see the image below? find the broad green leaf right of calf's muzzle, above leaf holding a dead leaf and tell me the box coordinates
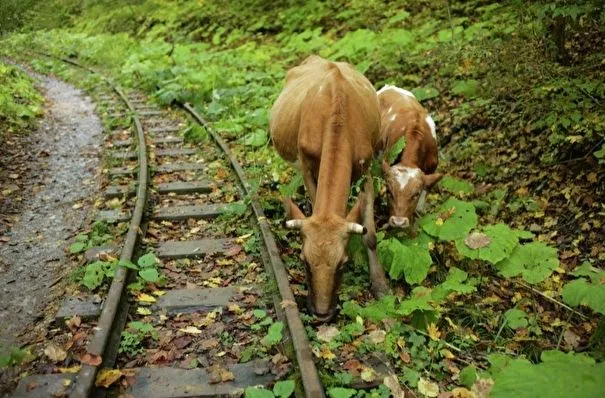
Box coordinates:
[419,198,477,240]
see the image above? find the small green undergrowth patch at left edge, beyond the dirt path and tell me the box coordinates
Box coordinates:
[0,62,44,142]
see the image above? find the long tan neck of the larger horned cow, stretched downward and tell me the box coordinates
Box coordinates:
[313,137,353,217]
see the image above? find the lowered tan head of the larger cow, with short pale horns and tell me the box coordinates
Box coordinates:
[284,199,366,321]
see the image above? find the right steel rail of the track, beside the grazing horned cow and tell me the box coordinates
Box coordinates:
[182,103,325,398]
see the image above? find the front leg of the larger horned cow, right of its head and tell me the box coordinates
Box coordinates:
[361,173,391,298]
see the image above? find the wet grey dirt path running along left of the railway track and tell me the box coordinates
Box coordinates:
[0,72,102,354]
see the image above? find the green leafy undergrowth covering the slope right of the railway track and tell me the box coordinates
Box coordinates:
[3,0,605,397]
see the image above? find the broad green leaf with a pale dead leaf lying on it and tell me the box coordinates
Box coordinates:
[456,224,519,264]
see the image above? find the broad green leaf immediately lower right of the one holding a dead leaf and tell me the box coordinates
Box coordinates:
[496,242,559,283]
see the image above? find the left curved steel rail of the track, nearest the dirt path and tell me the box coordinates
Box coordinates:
[38,52,149,398]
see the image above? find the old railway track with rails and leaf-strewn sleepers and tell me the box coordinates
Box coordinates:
[14,59,324,397]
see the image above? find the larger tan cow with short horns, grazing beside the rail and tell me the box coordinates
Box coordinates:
[270,56,388,320]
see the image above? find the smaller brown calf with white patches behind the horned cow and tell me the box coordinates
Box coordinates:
[377,85,443,228]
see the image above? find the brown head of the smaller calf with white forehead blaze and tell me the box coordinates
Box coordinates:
[382,161,443,228]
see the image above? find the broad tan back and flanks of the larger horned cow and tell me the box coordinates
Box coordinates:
[270,56,380,162]
